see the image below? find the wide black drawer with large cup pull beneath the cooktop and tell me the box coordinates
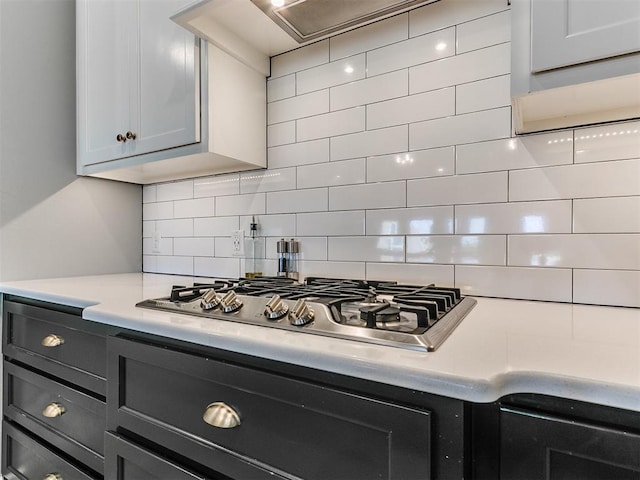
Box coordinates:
[108,338,431,480]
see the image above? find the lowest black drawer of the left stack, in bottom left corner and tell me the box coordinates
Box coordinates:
[2,422,100,480]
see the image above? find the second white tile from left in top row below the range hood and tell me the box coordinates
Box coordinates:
[329,13,409,61]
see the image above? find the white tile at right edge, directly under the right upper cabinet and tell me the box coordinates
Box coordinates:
[575,122,640,163]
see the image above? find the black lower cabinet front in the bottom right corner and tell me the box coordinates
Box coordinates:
[500,408,640,480]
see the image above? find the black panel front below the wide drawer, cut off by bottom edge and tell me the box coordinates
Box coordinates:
[104,432,205,480]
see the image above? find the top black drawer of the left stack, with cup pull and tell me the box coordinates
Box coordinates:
[3,301,106,395]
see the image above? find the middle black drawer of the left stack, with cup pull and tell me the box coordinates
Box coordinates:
[3,361,106,472]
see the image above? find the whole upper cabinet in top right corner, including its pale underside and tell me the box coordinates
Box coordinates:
[511,0,640,133]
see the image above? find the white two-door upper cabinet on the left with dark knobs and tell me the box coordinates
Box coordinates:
[76,0,266,184]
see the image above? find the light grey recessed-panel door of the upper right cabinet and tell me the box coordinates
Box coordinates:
[531,0,640,72]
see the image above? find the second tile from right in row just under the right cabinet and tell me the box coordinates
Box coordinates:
[456,132,573,174]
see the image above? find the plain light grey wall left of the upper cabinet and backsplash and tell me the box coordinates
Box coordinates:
[0,0,142,281]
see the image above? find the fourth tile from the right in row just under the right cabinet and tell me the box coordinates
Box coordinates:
[297,158,366,188]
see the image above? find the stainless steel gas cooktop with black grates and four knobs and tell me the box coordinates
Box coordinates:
[136,277,476,351]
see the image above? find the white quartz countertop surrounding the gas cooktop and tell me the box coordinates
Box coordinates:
[0,273,640,412]
